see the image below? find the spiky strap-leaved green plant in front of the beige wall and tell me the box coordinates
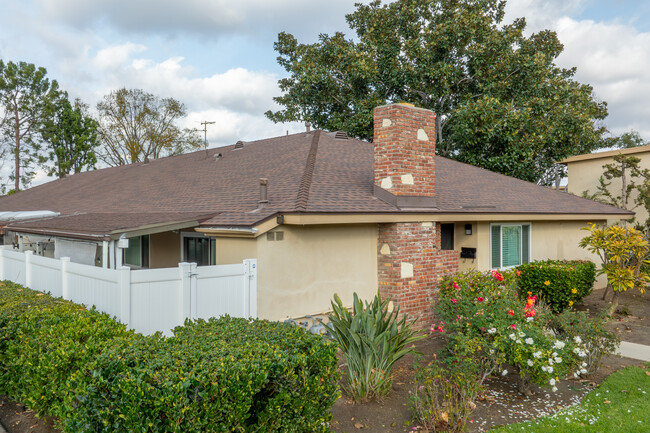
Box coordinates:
[328,293,424,401]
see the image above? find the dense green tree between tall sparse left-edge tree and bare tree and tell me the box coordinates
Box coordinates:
[42,92,99,178]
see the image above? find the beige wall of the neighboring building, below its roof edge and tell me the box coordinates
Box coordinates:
[567,152,650,222]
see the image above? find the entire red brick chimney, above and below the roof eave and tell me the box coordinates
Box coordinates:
[374,104,458,327]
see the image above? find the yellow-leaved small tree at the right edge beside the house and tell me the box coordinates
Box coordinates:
[580,224,650,314]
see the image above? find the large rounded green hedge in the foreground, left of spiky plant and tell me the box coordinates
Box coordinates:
[66,317,339,432]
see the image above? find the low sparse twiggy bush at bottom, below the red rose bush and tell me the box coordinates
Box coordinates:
[409,359,483,432]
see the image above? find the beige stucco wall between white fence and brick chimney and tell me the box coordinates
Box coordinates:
[257,224,377,320]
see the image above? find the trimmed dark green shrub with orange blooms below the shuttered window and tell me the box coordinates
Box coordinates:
[517,260,596,313]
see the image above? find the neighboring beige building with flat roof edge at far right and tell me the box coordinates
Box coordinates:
[560,145,650,222]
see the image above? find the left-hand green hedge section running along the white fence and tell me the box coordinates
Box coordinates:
[0,282,135,417]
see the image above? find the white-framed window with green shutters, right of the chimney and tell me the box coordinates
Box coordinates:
[490,224,530,269]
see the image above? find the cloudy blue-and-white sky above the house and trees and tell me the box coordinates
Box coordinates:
[0,0,650,183]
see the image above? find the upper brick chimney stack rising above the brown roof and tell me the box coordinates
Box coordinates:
[373,104,436,207]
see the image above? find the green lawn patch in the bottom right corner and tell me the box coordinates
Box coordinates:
[490,364,650,433]
